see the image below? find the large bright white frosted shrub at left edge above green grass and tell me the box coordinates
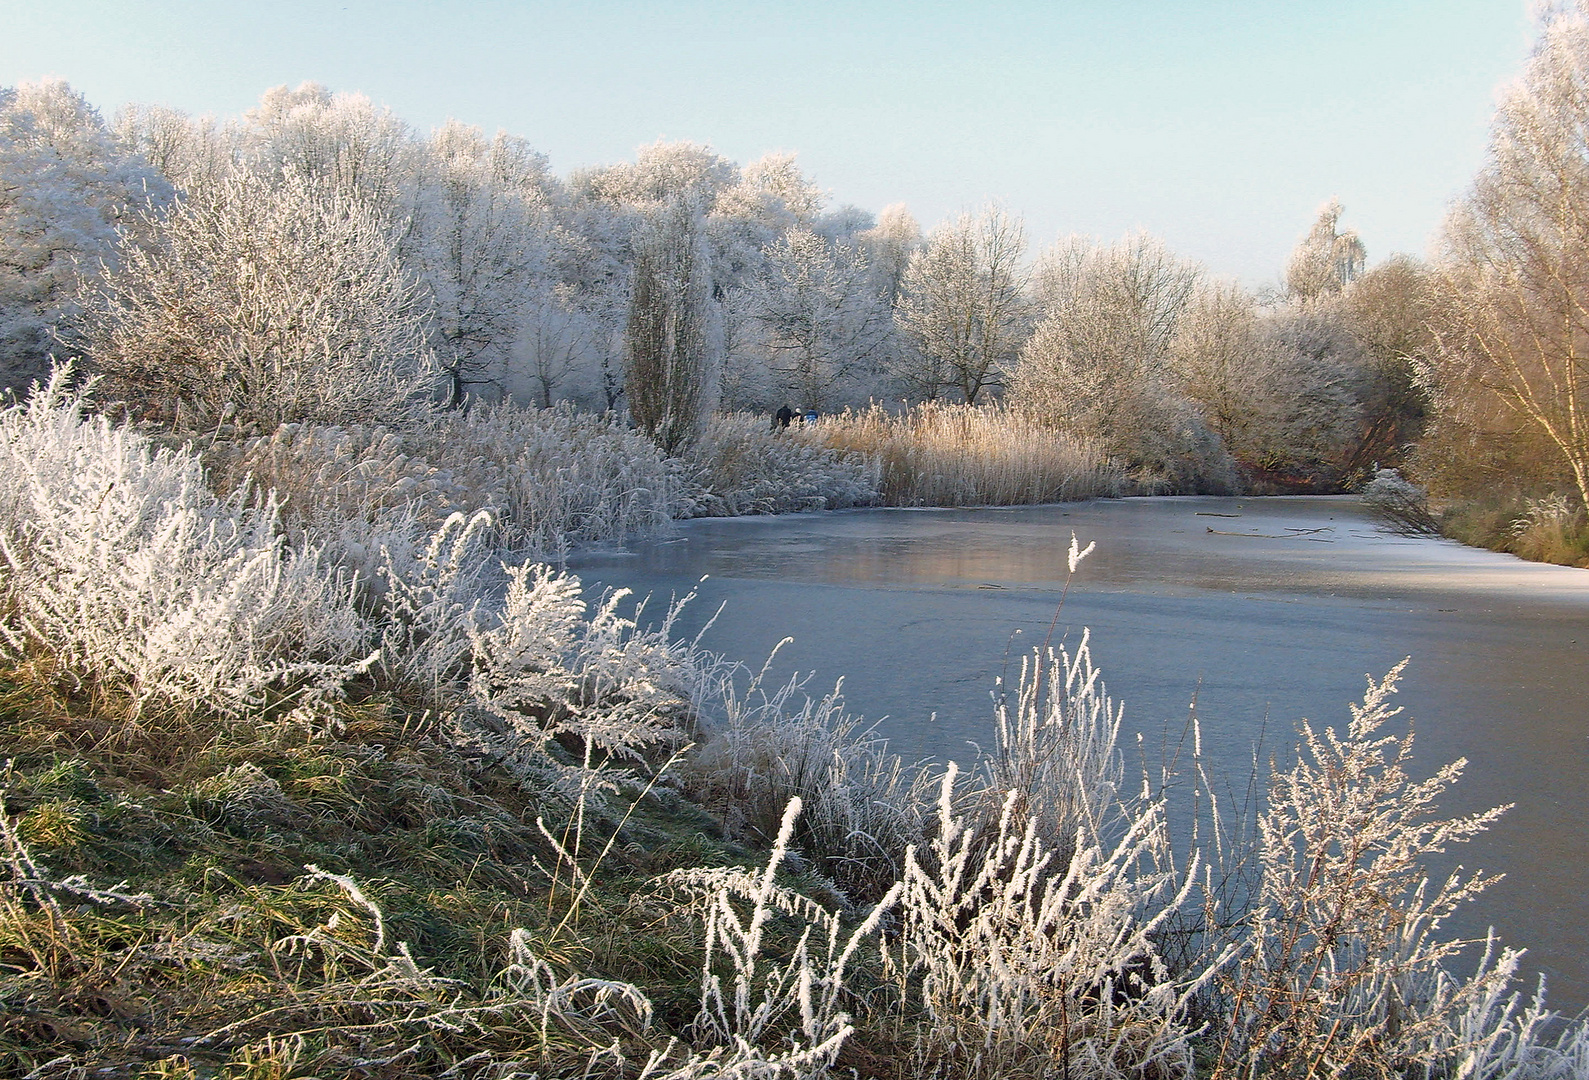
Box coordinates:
[0,370,369,713]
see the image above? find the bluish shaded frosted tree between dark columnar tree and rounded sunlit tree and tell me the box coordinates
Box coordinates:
[752,227,891,410]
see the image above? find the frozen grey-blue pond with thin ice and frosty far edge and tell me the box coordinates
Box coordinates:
[572,497,1589,1012]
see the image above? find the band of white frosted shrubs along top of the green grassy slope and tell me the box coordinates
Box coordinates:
[0,368,699,775]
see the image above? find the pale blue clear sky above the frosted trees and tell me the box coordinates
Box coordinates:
[0,0,1532,283]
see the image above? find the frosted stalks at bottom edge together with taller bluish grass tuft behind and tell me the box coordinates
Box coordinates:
[887,616,1227,1077]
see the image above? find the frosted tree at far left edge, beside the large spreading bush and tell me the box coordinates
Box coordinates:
[0,79,170,391]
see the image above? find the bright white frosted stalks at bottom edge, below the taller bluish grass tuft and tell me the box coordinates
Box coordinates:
[887,766,1201,1077]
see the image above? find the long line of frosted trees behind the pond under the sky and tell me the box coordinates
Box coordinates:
[9,83,1419,491]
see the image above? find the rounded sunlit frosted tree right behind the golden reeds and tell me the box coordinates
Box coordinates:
[895,206,1028,405]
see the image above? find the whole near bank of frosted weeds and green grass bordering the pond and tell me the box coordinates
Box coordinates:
[0,381,1589,1080]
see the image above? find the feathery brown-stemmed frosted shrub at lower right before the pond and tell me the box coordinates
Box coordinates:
[1216,662,1519,1077]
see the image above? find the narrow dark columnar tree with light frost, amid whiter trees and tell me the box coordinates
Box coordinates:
[624,199,713,454]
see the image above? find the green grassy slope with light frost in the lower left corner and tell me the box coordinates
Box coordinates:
[0,669,752,1077]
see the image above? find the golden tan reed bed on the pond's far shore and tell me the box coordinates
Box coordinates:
[791,402,1127,507]
